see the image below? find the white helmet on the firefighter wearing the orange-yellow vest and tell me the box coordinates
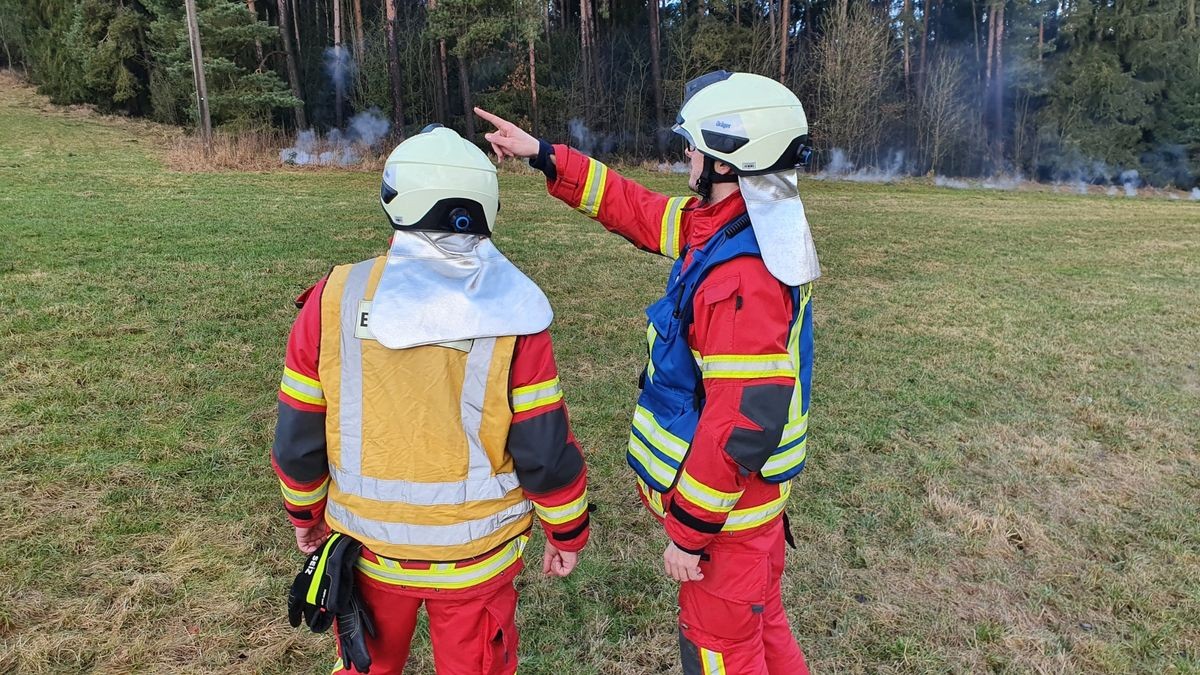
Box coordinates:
[379,124,500,237]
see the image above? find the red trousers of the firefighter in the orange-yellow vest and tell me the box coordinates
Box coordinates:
[334,565,521,675]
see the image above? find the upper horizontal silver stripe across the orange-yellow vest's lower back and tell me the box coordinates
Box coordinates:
[330,467,521,506]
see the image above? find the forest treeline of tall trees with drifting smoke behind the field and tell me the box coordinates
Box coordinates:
[0,0,1200,183]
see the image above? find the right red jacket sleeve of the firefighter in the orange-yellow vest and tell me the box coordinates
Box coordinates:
[508,330,589,551]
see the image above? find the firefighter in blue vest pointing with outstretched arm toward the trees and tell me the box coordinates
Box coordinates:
[476,71,820,675]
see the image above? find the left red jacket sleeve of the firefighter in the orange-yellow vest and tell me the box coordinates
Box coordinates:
[271,279,329,527]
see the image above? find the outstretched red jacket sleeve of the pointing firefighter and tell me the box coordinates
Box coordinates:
[546,145,695,259]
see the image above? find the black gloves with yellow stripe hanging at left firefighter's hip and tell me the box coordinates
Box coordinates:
[288,532,376,673]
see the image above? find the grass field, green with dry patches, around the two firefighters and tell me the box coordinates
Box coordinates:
[0,73,1200,675]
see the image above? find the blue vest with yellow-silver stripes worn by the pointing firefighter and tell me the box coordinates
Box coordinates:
[625,215,812,492]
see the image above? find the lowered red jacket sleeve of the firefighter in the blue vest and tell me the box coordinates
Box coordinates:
[666,257,796,554]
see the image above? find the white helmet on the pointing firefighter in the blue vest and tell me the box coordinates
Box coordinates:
[671,71,810,175]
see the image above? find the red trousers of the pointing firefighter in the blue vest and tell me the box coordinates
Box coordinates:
[679,519,809,675]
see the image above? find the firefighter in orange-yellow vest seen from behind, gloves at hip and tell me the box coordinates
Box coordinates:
[271,125,588,675]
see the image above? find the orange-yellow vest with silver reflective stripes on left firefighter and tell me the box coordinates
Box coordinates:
[318,257,533,561]
